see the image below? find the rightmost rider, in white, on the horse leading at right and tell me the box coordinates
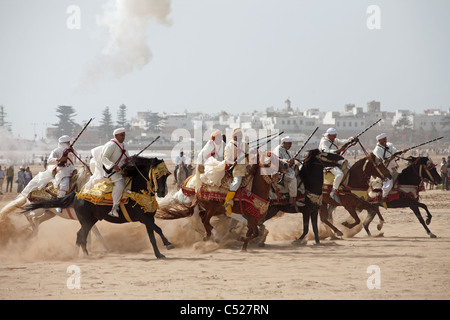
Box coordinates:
[373,133,408,199]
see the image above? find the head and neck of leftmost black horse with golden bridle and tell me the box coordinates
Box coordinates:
[124,157,171,198]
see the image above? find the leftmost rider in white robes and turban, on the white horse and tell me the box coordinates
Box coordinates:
[47,135,75,212]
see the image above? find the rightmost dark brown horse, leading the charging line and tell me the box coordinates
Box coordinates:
[363,157,442,238]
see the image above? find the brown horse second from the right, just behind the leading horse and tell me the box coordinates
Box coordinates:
[319,153,391,236]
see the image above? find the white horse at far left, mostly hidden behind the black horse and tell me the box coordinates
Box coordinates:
[0,167,109,251]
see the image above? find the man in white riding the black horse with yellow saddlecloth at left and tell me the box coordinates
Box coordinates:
[101,128,129,218]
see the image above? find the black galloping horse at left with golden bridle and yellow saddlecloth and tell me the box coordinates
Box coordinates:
[25,157,173,259]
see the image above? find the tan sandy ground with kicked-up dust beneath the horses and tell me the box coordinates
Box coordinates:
[0,162,450,300]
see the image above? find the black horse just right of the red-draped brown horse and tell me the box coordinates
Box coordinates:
[260,149,344,245]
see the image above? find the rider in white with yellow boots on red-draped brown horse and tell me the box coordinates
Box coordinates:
[224,128,248,215]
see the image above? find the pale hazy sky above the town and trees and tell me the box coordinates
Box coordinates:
[0,0,450,138]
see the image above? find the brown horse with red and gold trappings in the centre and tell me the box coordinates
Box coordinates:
[158,152,284,251]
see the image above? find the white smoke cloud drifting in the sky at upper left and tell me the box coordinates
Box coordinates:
[83,0,172,86]
